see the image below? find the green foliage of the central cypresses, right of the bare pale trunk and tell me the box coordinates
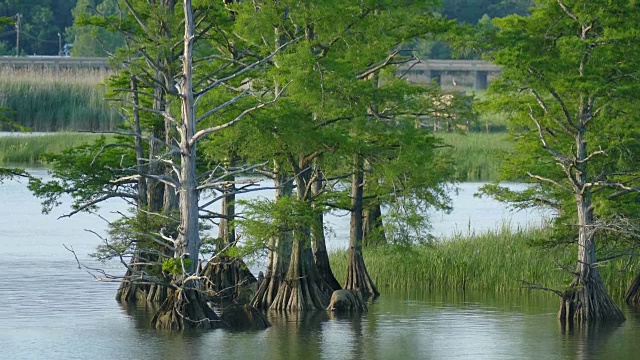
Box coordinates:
[210,1,464,245]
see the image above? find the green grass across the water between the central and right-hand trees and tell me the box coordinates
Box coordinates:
[437,133,511,181]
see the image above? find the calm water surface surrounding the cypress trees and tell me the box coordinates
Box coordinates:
[0,171,640,360]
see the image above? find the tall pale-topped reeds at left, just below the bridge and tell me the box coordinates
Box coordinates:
[0,69,118,132]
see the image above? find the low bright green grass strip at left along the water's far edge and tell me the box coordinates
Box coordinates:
[0,133,106,166]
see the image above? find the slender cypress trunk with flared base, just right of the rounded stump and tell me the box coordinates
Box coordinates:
[344,153,380,297]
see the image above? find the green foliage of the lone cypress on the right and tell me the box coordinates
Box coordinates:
[484,1,640,246]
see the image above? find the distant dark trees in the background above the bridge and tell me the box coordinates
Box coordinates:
[0,0,533,58]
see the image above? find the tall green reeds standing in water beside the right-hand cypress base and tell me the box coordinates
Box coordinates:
[330,229,640,299]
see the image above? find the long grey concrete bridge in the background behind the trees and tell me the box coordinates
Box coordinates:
[0,56,500,89]
